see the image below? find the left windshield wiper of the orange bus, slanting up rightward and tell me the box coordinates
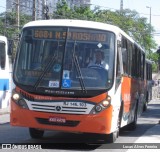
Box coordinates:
[34,50,58,90]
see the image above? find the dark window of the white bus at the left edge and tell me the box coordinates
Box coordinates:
[0,43,6,69]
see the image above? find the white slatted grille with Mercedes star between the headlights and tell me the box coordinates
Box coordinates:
[26,100,95,114]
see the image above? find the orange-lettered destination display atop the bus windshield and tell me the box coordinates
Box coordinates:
[33,30,107,42]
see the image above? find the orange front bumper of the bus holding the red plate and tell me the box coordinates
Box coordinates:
[10,102,113,134]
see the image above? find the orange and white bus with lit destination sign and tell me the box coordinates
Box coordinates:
[10,20,145,142]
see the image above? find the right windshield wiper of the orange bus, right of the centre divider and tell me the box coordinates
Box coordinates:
[72,41,87,93]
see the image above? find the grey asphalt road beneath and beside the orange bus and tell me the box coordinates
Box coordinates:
[0,100,160,152]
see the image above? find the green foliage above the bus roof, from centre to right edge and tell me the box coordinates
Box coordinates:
[53,0,157,67]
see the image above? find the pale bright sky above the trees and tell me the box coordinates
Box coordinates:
[0,0,160,46]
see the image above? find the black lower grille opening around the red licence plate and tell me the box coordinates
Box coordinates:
[36,118,80,127]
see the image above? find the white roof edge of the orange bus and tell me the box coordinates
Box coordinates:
[23,19,144,51]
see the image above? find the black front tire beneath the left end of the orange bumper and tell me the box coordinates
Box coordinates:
[29,128,44,139]
